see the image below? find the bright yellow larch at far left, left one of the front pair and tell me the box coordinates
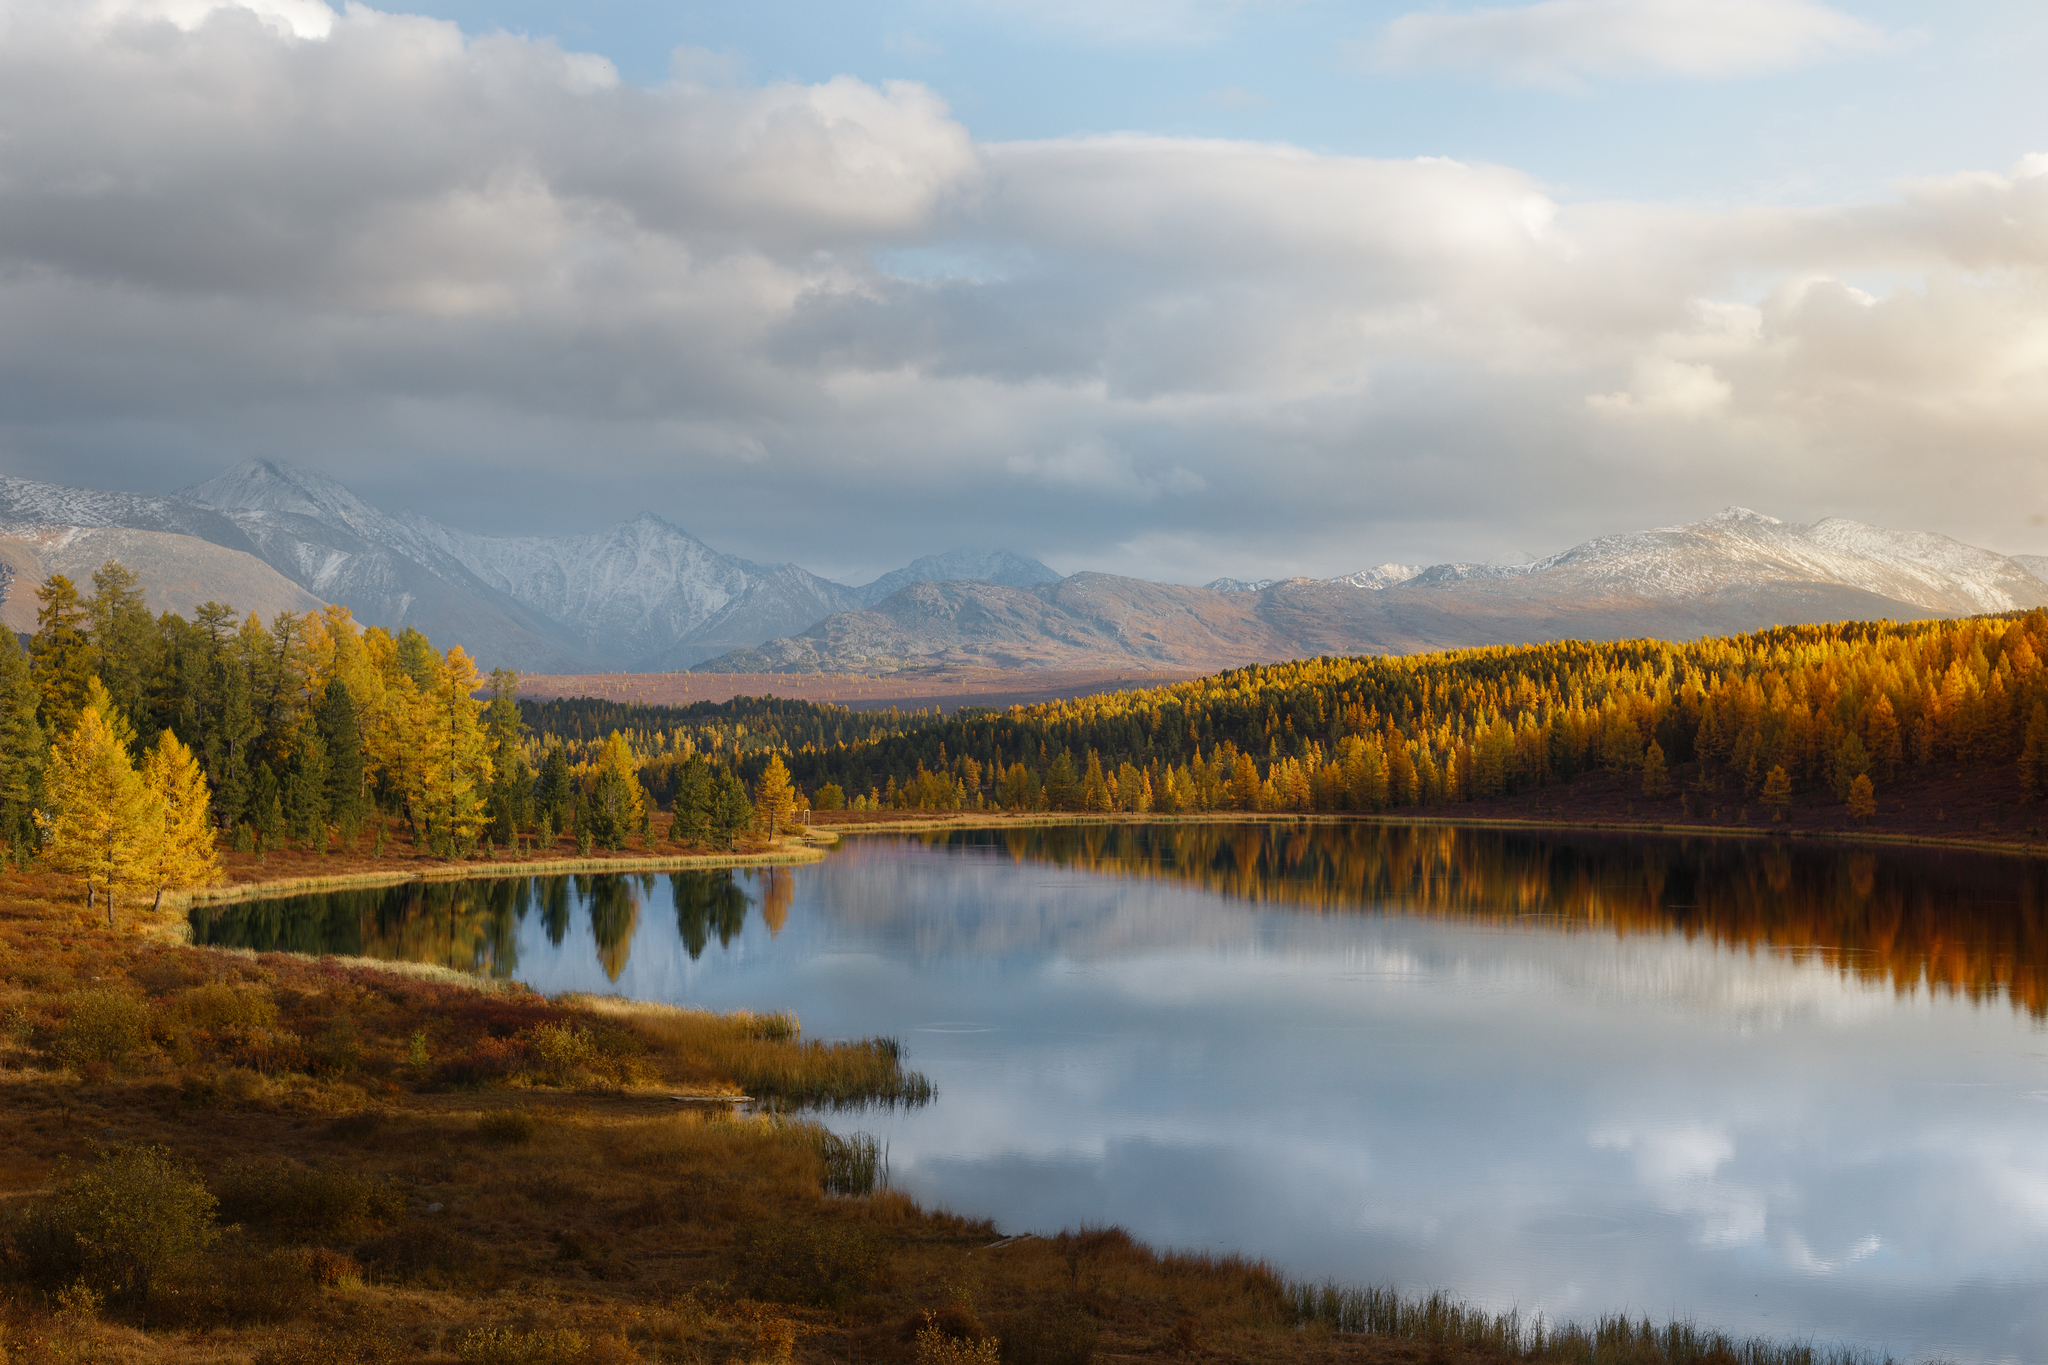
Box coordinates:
[45,677,164,929]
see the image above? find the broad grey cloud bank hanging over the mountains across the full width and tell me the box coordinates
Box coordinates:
[0,0,2048,581]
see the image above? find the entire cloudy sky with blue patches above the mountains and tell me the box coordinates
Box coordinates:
[0,0,2048,583]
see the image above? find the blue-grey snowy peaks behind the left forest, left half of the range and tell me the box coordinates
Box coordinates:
[0,460,1059,673]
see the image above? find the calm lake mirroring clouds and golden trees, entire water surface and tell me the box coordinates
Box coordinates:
[195,825,2048,1361]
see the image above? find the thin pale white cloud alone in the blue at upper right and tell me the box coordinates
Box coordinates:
[1366,0,1884,88]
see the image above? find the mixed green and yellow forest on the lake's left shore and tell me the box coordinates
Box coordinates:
[0,563,801,898]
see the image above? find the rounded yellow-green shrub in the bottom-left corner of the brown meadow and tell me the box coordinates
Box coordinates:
[12,1146,219,1295]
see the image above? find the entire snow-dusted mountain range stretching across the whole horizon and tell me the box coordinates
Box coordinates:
[0,460,2048,673]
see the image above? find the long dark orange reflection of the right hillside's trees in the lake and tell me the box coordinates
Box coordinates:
[924,825,2048,1019]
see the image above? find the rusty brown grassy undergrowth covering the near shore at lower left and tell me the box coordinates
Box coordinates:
[0,872,1900,1365]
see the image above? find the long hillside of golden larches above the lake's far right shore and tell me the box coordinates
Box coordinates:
[753,610,2048,812]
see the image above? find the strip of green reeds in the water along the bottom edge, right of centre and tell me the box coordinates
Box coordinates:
[1284,1281,1892,1365]
